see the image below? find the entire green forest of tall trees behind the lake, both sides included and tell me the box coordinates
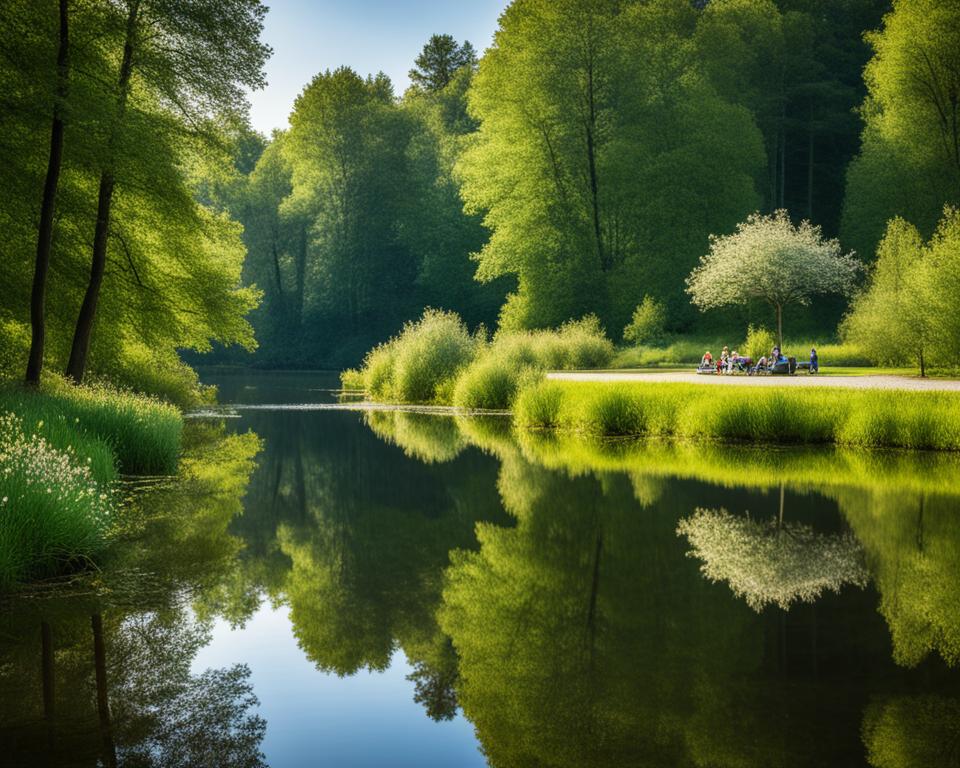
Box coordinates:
[0,0,960,384]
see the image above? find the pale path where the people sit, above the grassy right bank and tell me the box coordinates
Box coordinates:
[547,371,960,392]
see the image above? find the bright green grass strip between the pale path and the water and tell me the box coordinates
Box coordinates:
[515,381,960,451]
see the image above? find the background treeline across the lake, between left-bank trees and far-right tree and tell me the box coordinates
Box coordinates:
[206,0,920,365]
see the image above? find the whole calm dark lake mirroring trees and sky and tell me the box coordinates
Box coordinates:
[0,372,960,768]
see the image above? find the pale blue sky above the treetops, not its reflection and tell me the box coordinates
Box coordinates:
[250,0,508,134]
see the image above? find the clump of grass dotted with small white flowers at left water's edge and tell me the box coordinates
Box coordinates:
[0,413,113,587]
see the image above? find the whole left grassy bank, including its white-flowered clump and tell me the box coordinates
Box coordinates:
[0,381,183,588]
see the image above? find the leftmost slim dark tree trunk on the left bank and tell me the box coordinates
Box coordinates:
[26,0,70,386]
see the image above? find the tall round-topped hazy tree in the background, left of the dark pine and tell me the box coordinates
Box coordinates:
[283,67,415,350]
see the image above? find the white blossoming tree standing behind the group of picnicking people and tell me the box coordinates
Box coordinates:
[687,210,863,349]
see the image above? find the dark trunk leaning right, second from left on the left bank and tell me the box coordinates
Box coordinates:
[66,0,140,384]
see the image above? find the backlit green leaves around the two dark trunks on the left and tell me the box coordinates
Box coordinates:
[0,0,268,390]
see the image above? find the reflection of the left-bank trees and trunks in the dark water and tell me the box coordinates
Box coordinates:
[0,425,265,768]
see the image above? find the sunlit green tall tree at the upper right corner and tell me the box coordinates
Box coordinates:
[843,0,960,253]
